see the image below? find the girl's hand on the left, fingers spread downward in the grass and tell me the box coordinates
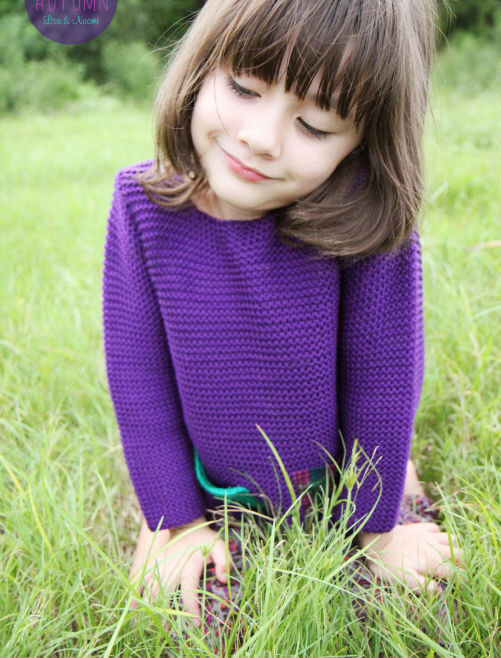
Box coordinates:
[129,517,231,627]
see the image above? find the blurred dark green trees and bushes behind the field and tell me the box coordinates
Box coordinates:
[0,0,501,114]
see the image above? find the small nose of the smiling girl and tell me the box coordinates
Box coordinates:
[238,107,284,159]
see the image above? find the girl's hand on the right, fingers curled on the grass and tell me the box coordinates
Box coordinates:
[359,523,463,591]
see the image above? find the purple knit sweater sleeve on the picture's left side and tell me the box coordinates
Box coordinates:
[103,172,206,530]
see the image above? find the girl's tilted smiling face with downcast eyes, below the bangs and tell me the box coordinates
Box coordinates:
[191,67,362,219]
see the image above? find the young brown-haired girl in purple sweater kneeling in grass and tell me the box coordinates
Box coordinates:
[103,0,460,644]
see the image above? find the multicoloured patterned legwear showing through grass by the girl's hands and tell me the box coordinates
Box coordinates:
[164,494,459,656]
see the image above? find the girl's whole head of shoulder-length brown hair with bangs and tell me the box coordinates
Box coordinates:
[137,0,436,257]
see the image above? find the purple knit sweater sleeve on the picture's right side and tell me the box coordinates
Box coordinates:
[338,232,424,532]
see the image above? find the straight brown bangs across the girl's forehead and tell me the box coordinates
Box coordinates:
[213,0,367,123]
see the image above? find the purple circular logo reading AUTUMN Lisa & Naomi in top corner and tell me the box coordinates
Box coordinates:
[25,0,118,45]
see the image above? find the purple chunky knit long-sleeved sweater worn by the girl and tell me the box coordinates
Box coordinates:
[103,161,424,532]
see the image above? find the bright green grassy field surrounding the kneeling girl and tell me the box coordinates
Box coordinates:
[0,34,501,658]
